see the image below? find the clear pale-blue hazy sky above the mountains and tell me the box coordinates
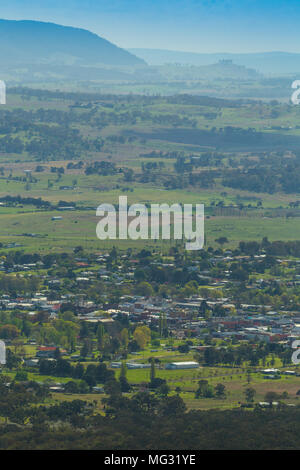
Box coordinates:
[0,0,300,52]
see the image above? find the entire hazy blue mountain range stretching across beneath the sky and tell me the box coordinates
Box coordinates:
[0,19,300,86]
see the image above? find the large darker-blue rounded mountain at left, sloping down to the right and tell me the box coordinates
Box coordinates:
[0,20,146,66]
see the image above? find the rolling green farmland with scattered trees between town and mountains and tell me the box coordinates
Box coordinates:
[0,89,300,251]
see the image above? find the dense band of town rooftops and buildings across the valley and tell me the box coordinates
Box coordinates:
[0,277,300,348]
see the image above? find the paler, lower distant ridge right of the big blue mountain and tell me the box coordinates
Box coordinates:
[128,48,300,75]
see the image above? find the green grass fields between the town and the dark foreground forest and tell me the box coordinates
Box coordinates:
[4,340,300,413]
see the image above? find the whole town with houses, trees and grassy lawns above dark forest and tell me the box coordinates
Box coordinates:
[0,239,300,412]
